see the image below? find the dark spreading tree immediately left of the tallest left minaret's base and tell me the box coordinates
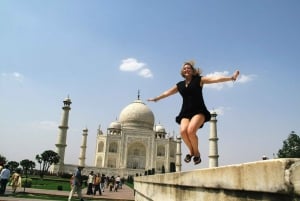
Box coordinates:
[35,150,60,178]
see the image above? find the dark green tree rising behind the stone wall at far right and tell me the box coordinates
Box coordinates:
[277,131,300,158]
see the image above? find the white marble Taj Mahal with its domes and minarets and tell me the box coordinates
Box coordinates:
[50,94,218,178]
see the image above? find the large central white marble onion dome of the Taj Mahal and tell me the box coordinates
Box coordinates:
[119,99,154,130]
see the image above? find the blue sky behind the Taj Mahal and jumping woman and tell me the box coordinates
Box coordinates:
[0,0,300,170]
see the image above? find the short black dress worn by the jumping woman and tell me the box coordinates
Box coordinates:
[176,76,211,128]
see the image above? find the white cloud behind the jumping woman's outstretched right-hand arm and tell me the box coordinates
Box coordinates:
[205,71,255,90]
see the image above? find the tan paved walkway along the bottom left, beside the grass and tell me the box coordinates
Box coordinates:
[0,185,134,201]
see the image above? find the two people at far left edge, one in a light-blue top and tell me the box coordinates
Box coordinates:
[0,165,22,195]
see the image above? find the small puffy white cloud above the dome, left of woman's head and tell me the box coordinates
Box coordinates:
[120,58,153,78]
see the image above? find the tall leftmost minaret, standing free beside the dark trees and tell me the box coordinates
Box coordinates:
[54,97,72,173]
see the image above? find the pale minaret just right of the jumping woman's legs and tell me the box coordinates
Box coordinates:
[208,112,219,168]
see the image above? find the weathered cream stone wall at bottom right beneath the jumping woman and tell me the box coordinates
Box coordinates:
[134,159,300,201]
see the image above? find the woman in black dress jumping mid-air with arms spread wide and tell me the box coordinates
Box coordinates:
[148,61,239,165]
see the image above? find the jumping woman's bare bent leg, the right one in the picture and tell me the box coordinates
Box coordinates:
[187,114,205,157]
